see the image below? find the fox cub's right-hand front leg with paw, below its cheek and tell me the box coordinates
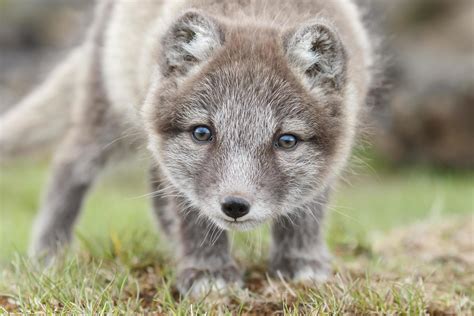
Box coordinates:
[270,190,330,282]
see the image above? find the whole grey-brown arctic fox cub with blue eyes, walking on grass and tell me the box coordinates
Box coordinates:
[0,0,373,293]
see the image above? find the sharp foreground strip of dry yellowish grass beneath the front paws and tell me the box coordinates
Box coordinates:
[0,216,474,315]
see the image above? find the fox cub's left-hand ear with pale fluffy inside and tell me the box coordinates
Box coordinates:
[161,11,224,75]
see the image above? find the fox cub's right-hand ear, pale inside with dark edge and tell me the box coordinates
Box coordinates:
[283,24,346,90]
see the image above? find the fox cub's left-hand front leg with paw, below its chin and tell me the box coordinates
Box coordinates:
[159,198,241,297]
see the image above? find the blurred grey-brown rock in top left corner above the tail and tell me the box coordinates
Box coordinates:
[0,0,93,113]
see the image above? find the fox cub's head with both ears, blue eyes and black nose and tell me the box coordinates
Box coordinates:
[143,11,346,230]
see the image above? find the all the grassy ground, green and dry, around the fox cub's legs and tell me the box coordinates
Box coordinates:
[0,153,474,315]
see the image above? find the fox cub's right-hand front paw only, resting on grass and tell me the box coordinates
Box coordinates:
[270,258,331,284]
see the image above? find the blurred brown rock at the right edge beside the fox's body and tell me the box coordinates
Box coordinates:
[374,0,474,168]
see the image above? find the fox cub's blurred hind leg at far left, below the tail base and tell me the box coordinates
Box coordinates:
[30,77,126,260]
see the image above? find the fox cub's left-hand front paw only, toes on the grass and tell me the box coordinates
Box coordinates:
[176,265,243,298]
